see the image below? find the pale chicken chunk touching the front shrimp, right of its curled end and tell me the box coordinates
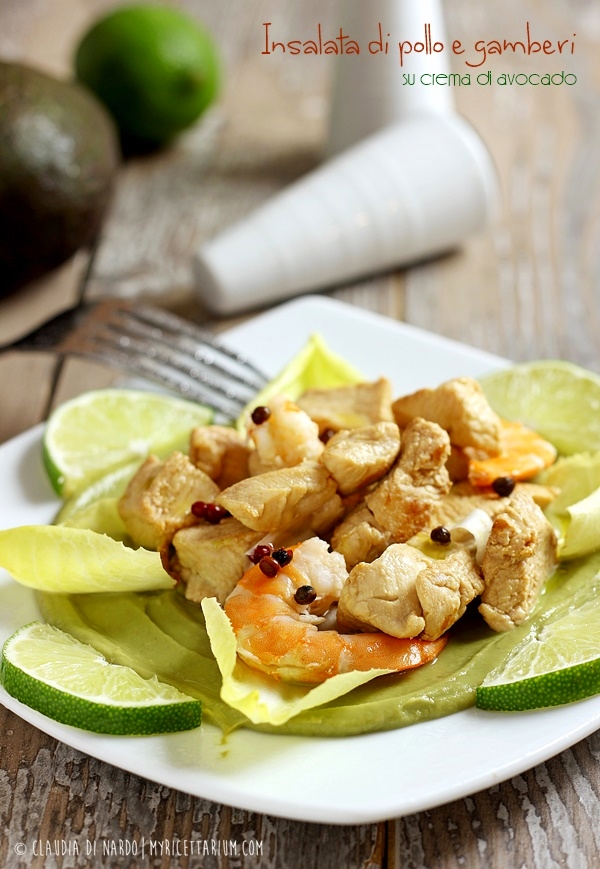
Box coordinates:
[337,543,430,637]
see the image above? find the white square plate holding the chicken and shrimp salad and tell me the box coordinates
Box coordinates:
[0,297,600,824]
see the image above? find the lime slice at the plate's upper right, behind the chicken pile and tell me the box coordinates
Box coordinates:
[481,360,600,455]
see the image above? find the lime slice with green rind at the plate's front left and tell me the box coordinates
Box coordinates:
[0,622,202,735]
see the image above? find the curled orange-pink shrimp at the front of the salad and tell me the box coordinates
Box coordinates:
[225,538,446,683]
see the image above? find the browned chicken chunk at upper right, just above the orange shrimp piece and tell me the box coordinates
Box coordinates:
[392,377,501,455]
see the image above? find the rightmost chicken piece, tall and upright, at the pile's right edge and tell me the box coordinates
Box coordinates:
[479,492,557,631]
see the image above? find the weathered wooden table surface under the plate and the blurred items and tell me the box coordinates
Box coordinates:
[0,0,600,869]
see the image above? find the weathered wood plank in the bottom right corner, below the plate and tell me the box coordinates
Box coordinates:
[390,733,600,869]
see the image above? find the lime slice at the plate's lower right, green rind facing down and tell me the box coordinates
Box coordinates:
[476,577,600,711]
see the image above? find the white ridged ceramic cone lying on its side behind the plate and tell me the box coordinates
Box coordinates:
[194,114,496,315]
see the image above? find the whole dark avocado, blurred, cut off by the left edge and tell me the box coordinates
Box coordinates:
[0,62,120,295]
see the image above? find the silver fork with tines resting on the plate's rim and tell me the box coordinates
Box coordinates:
[0,300,268,420]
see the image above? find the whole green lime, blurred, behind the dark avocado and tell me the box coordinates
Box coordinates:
[75,4,219,144]
